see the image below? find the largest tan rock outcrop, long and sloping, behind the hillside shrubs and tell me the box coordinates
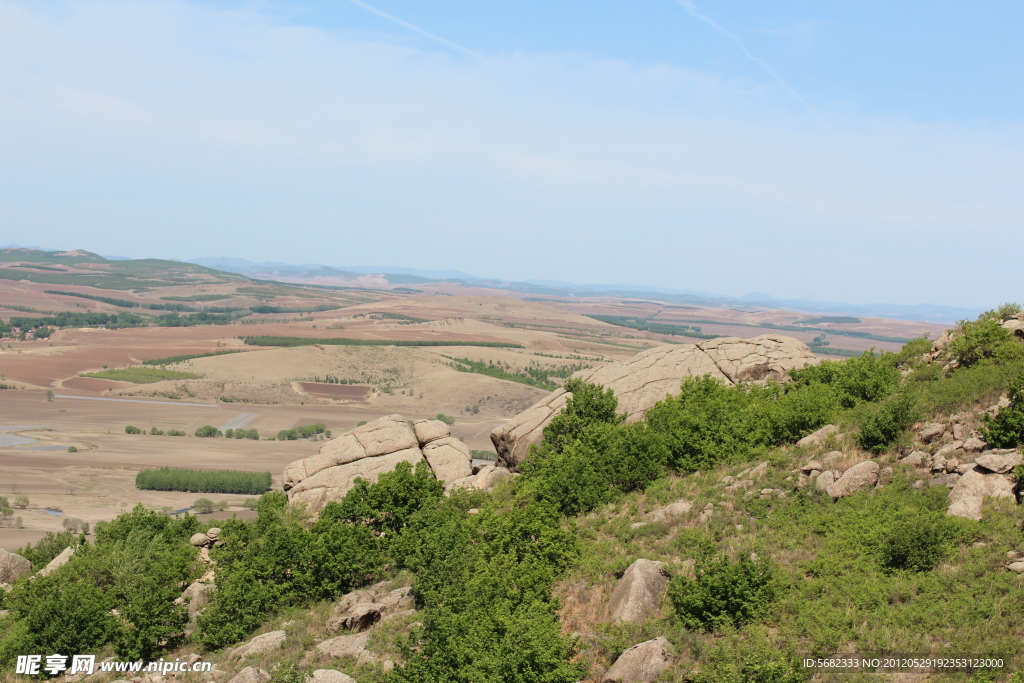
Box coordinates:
[490,335,818,469]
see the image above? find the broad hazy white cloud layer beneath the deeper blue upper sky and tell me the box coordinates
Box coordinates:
[0,0,1024,305]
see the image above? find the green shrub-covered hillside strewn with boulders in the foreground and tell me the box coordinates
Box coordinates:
[0,307,1024,683]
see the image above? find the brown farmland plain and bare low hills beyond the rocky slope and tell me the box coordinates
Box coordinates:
[0,264,943,548]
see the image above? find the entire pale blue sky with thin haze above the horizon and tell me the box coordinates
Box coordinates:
[0,0,1024,307]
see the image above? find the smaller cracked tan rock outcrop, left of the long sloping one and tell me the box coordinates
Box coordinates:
[284,415,473,511]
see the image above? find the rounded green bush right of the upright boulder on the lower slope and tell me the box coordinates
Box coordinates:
[668,553,779,631]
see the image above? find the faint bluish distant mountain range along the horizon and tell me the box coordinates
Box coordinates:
[187,256,984,324]
